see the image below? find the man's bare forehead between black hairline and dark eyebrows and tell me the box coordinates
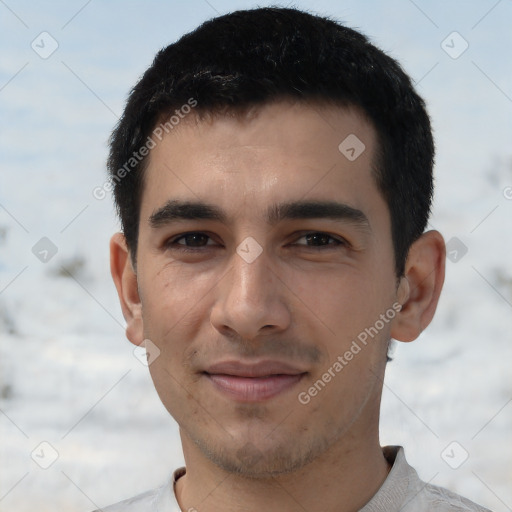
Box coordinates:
[141,103,382,222]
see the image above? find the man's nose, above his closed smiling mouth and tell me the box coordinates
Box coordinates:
[211,249,291,341]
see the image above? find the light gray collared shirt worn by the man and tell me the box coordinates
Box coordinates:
[94,446,490,512]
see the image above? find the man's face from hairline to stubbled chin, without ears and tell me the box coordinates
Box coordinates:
[131,103,398,477]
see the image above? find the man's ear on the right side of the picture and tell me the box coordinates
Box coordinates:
[391,231,446,341]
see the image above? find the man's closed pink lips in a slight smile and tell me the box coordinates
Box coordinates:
[204,361,307,402]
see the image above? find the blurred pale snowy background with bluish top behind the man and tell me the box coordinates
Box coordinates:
[0,0,512,512]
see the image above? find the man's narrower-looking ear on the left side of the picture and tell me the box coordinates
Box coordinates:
[110,233,144,345]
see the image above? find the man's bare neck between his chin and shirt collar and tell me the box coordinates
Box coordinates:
[176,425,390,512]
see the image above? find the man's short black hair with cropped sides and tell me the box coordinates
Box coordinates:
[108,7,434,277]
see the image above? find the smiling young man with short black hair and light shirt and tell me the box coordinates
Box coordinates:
[104,8,492,512]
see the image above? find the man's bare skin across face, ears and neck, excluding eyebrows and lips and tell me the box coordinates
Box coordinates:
[111,103,445,512]
